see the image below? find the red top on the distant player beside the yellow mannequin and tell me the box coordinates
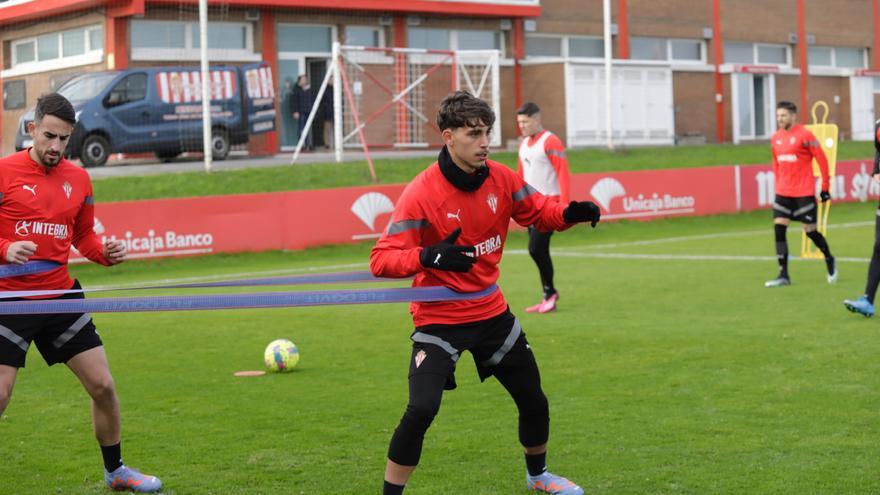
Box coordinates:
[770,124,830,198]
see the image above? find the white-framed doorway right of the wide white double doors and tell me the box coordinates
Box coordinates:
[731,72,776,143]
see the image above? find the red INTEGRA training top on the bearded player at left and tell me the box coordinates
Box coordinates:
[0,148,110,291]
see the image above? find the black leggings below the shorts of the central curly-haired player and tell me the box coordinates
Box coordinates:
[388,360,550,466]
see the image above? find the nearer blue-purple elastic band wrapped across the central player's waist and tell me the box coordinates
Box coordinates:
[0,284,498,315]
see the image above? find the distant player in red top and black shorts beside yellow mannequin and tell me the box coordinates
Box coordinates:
[764,101,837,287]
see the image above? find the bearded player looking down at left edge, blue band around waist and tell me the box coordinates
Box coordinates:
[0,93,162,492]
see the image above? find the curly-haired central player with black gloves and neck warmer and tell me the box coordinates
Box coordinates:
[370,92,599,495]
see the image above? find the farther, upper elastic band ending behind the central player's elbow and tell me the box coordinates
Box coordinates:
[0,270,392,299]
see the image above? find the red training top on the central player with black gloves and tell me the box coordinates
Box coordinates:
[370,160,572,327]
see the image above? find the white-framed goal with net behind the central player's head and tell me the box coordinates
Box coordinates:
[328,45,501,167]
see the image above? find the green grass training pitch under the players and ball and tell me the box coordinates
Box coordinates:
[0,204,880,495]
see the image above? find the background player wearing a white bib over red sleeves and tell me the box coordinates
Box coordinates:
[516,101,570,313]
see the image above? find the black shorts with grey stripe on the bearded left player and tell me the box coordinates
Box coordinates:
[0,281,103,368]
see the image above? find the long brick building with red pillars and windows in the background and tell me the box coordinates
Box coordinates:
[0,0,880,154]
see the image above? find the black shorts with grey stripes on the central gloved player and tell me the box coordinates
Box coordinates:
[409,308,535,390]
